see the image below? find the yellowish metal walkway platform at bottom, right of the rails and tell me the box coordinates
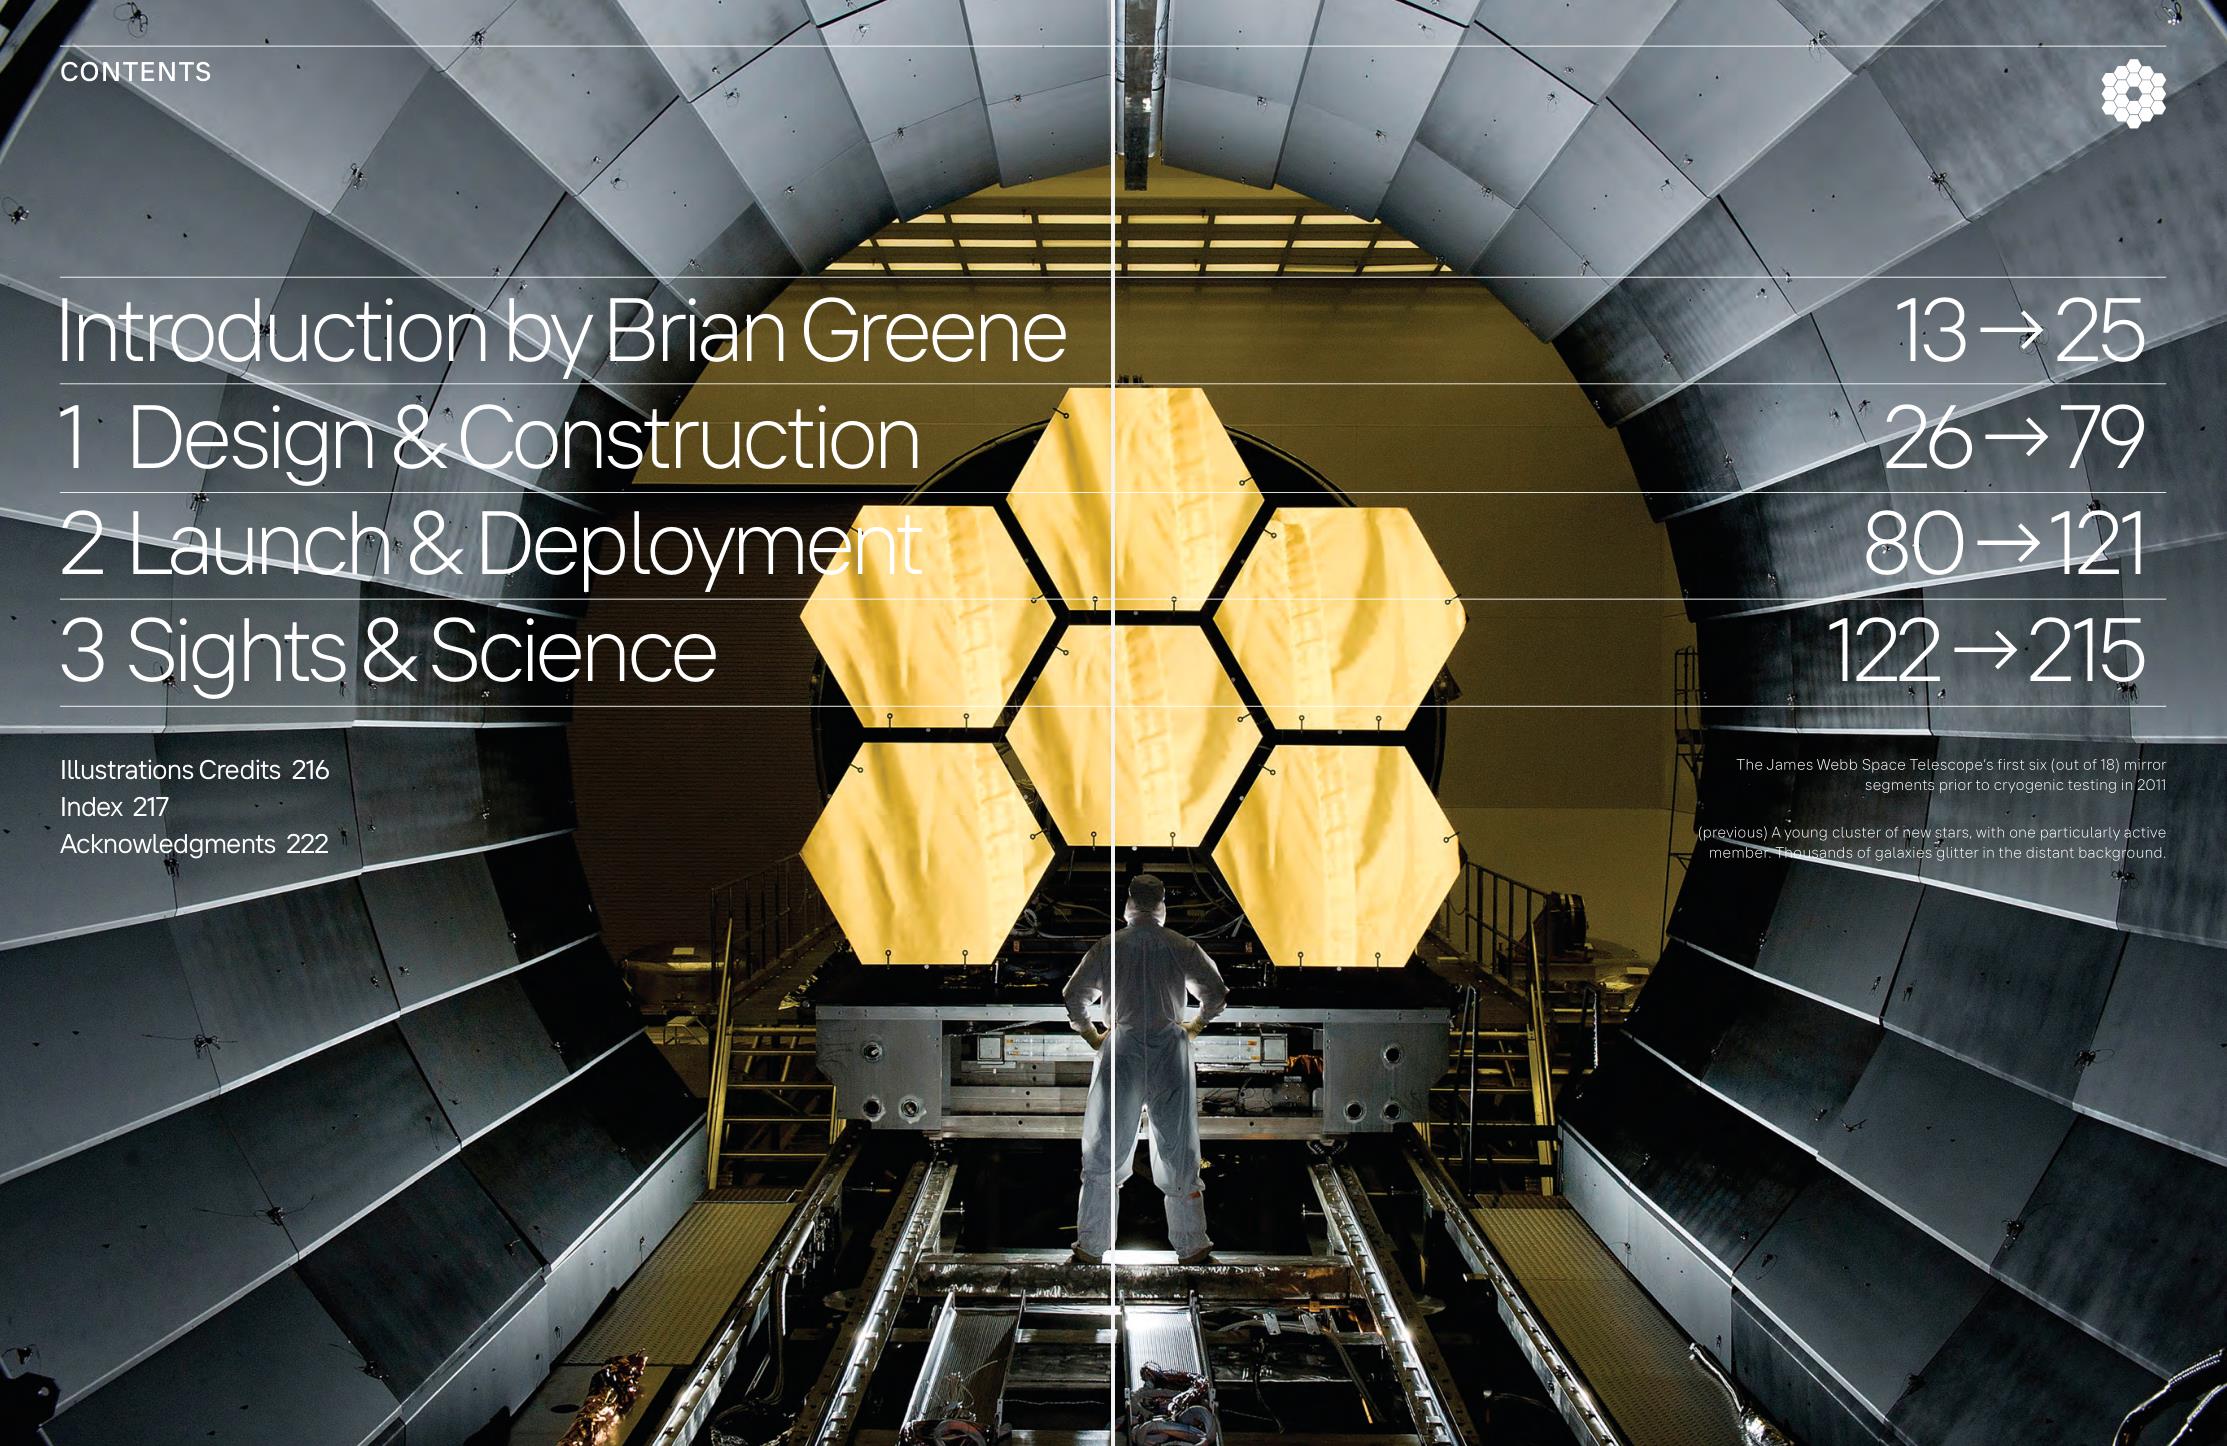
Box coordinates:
[1470,1194,1735,1446]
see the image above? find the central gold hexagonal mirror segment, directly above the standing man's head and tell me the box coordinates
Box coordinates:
[1009,624,1260,849]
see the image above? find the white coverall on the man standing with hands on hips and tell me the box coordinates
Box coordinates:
[1065,907,1229,1254]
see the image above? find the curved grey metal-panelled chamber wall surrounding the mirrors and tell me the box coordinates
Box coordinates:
[0,0,2227,1444]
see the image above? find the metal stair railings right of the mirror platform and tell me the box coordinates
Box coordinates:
[1436,858,1572,1183]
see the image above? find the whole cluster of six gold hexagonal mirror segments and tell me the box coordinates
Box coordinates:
[804,388,1465,967]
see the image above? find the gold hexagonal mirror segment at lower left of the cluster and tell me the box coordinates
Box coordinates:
[804,742,1051,965]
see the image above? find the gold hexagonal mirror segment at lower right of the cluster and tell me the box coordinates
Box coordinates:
[1214,744,1461,969]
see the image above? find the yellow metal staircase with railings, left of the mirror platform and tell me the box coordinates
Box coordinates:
[706,853,842,1190]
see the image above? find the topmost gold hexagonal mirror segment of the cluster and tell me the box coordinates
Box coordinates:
[1011,388,1260,610]
